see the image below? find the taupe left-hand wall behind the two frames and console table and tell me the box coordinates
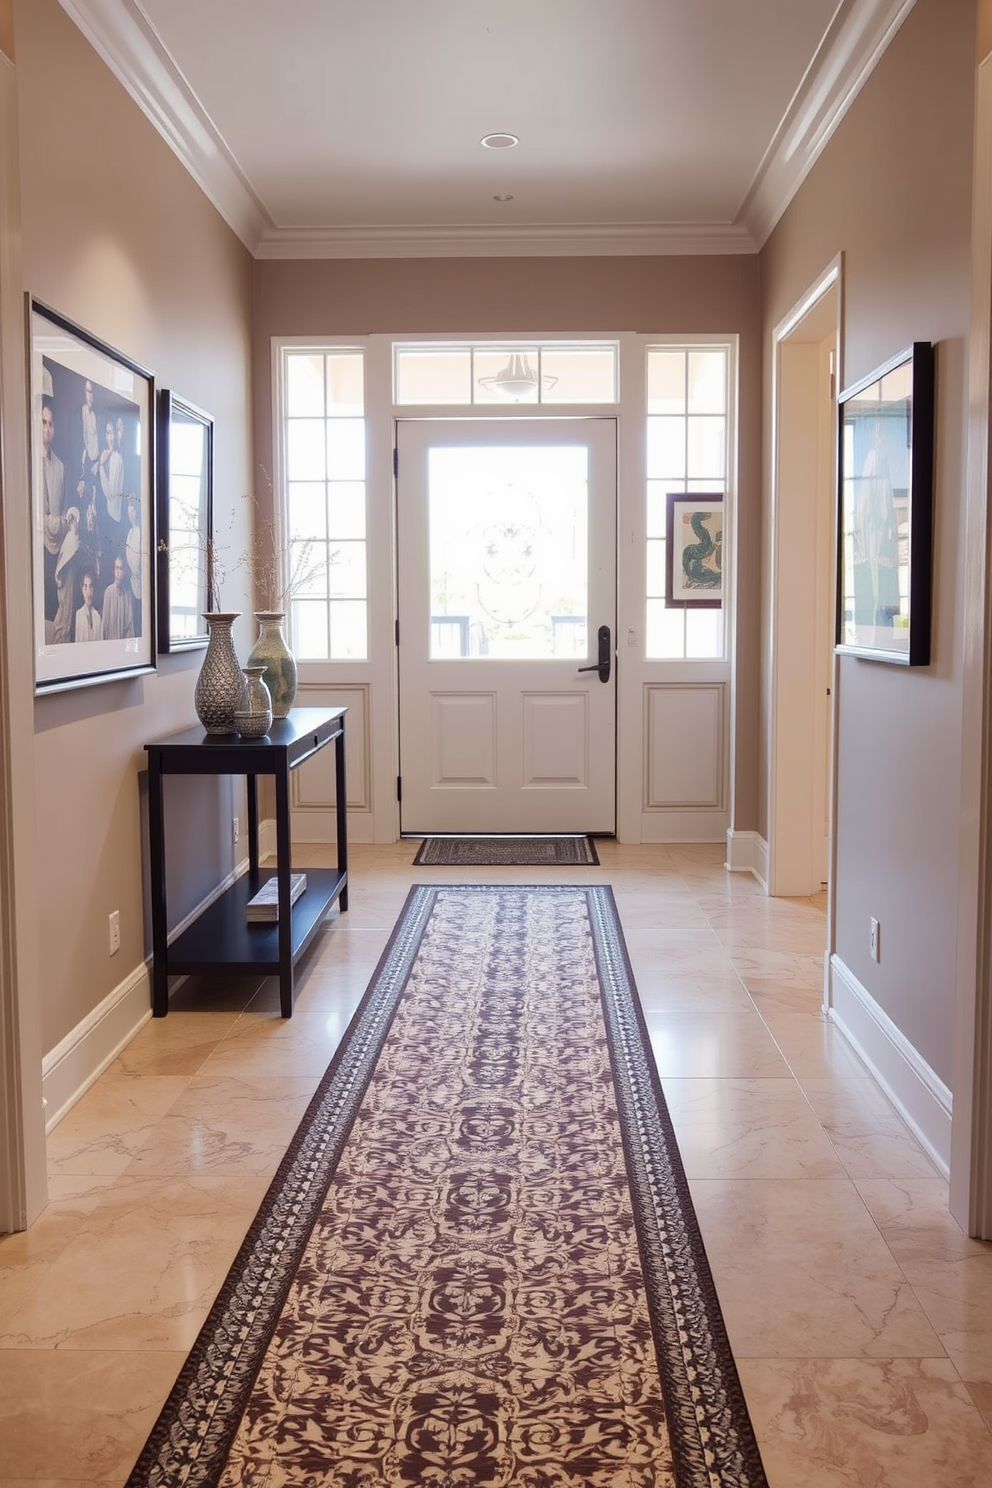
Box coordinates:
[13,0,253,1051]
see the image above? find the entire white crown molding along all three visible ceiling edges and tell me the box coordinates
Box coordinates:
[59,0,915,259]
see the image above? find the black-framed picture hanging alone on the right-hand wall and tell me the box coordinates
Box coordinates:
[837,341,934,667]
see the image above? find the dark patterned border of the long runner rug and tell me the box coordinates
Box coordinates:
[126,884,766,1488]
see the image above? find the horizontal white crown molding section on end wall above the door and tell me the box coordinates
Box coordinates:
[254,222,756,259]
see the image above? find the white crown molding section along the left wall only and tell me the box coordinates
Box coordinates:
[58,0,274,253]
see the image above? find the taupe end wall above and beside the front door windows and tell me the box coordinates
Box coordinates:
[254,256,760,830]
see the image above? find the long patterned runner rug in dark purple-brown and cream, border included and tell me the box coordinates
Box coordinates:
[128,885,766,1488]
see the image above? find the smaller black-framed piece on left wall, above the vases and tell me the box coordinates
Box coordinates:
[156,388,214,652]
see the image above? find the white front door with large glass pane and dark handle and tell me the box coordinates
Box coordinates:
[397,418,617,833]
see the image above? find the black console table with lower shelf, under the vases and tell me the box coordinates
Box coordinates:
[144,708,348,1018]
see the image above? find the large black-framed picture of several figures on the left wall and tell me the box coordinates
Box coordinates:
[28,299,155,693]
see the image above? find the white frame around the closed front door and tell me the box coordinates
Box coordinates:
[393,405,620,836]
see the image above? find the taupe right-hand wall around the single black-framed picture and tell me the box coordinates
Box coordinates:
[761,0,976,1085]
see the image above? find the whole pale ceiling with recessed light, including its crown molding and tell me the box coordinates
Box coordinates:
[59,0,915,257]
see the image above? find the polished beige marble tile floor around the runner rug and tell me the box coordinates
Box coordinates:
[0,842,992,1488]
